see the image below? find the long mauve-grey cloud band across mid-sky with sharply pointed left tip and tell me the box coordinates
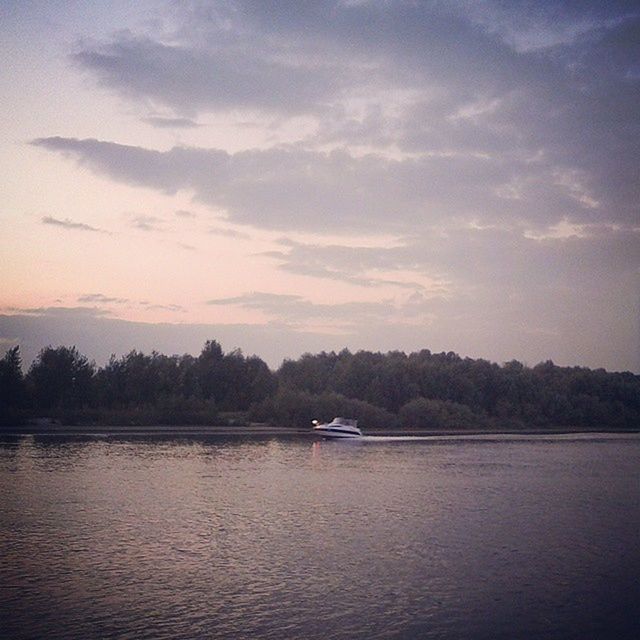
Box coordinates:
[33,137,625,234]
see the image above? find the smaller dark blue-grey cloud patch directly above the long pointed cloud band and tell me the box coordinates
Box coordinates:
[73,33,344,113]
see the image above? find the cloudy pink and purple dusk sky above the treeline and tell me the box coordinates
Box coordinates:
[0,0,640,373]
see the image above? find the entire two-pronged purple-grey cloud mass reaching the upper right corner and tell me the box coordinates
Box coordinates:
[35,0,640,233]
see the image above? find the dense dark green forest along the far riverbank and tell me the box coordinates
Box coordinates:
[0,340,640,430]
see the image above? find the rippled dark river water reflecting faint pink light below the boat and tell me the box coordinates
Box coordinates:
[0,435,640,640]
